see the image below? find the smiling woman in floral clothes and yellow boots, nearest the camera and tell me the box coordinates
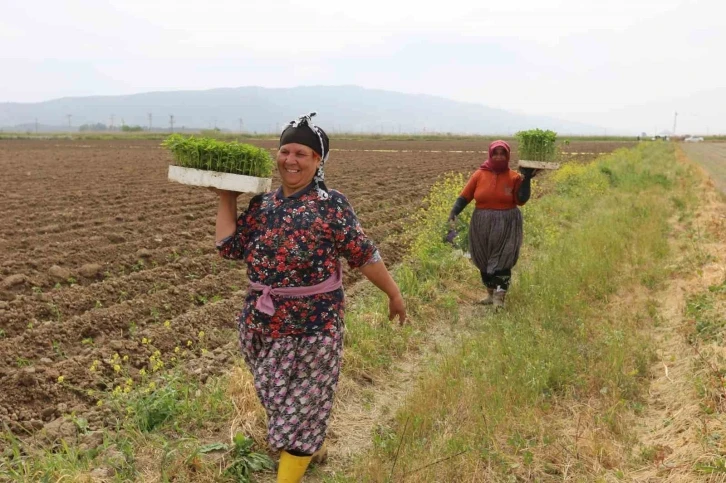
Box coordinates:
[216,113,406,482]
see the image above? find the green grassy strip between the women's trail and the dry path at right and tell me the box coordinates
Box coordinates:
[336,144,693,481]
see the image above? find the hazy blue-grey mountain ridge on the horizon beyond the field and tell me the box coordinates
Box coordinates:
[0,86,603,134]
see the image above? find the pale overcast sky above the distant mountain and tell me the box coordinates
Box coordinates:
[0,0,726,134]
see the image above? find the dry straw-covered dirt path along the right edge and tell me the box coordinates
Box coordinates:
[628,149,726,482]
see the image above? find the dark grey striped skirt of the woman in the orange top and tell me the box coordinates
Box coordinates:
[469,207,523,275]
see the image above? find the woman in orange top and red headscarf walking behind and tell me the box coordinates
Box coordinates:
[449,140,536,308]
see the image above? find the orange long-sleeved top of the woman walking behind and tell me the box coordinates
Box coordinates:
[460,169,524,210]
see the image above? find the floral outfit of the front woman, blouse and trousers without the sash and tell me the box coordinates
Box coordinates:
[217,184,380,454]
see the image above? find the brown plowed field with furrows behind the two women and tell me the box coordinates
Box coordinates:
[0,140,628,432]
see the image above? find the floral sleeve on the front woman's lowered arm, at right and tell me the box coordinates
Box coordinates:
[334,193,381,268]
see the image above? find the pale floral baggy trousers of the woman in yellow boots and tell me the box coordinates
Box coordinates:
[238,322,344,454]
